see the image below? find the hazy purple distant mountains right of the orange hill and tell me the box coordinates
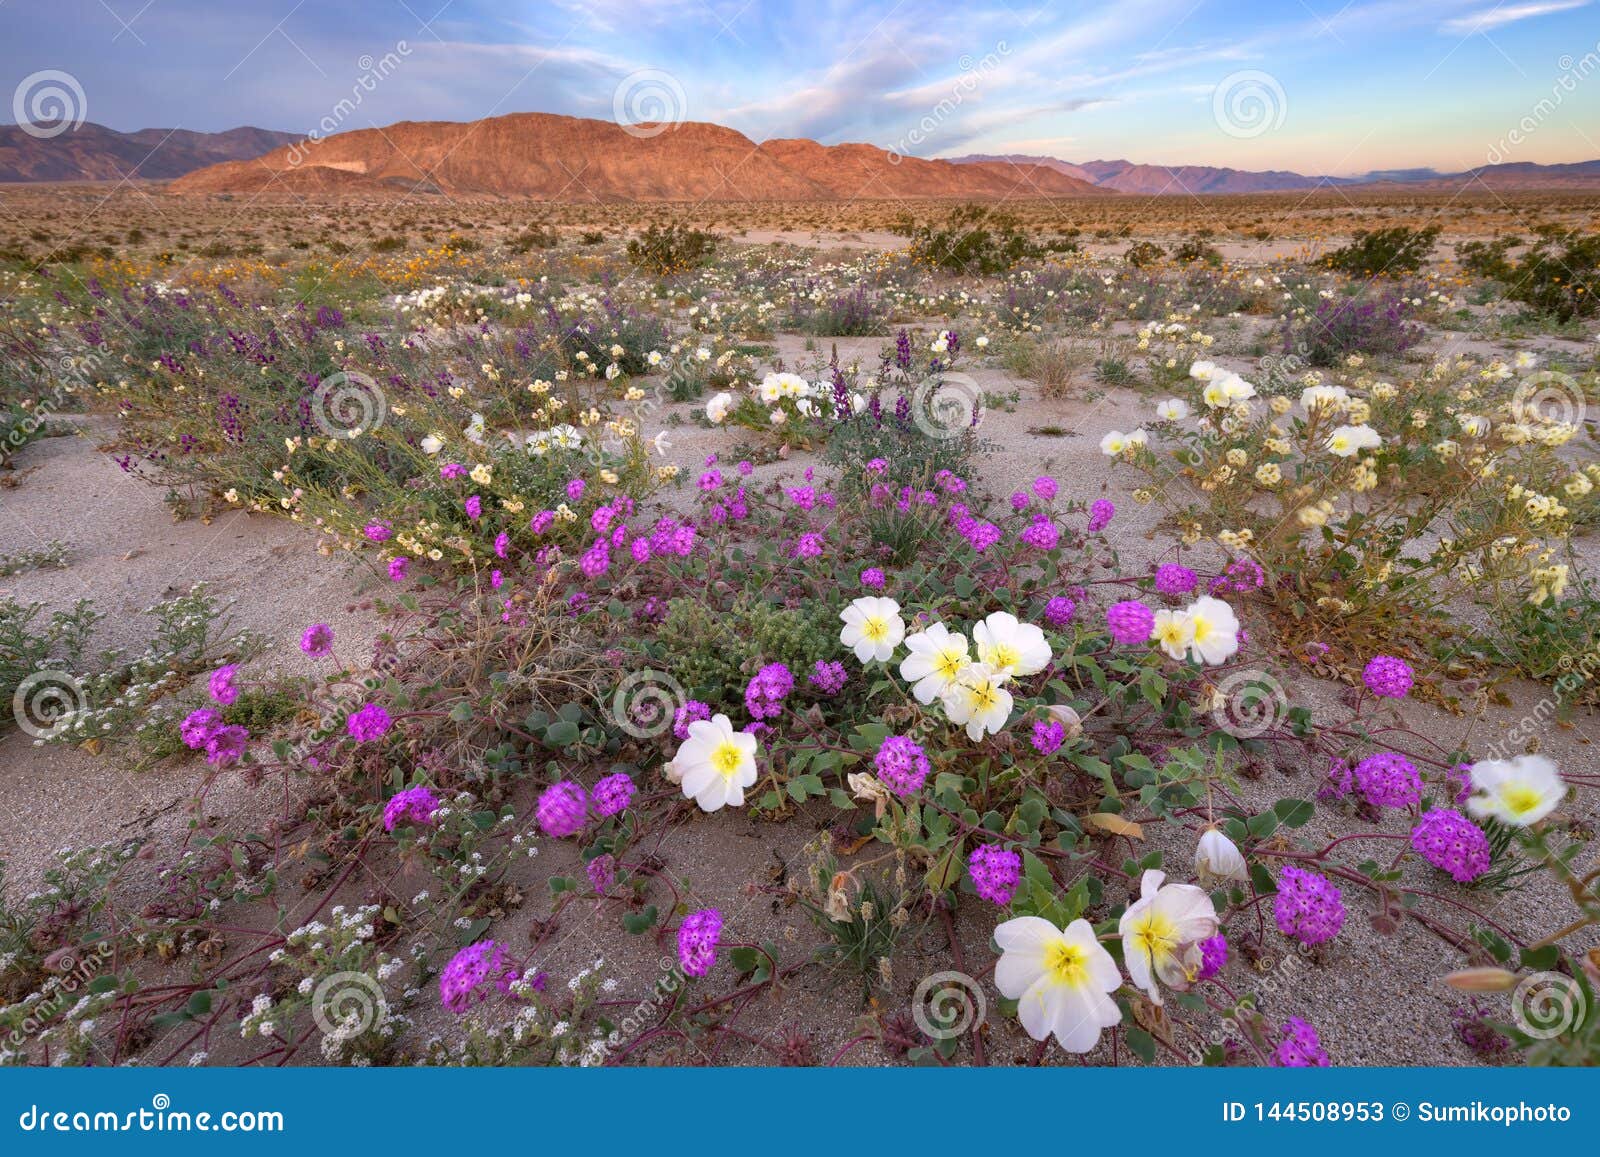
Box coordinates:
[952,154,1600,197]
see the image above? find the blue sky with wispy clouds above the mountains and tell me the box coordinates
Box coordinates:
[0,0,1600,174]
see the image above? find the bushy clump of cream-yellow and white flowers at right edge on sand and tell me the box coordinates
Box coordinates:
[1102,355,1600,678]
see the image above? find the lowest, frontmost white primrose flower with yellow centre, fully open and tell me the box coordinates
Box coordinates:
[995,915,1122,1053]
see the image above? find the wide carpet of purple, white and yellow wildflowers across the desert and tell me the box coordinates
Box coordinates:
[12,222,1600,1067]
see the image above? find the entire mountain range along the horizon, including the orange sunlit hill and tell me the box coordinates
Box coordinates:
[0,112,1600,202]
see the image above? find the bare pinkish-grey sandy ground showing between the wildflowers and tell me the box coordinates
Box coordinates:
[0,302,1600,1064]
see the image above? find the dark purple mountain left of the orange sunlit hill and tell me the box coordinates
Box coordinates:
[0,122,299,181]
